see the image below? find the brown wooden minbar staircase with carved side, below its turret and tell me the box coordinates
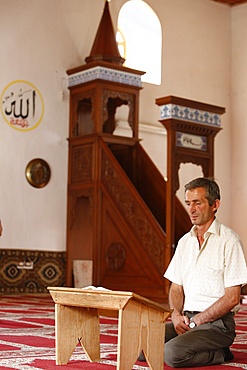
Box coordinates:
[67,134,190,302]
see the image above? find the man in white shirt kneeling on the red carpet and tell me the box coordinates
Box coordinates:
[164,177,247,367]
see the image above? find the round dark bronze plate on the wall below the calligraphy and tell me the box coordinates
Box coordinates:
[26,158,51,188]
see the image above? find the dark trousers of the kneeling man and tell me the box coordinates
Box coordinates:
[165,313,236,367]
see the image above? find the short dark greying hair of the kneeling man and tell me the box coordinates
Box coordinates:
[184,177,220,206]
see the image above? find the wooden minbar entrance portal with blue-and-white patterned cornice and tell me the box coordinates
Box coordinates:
[156,96,225,255]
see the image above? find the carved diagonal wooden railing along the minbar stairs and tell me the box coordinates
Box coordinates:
[101,141,165,273]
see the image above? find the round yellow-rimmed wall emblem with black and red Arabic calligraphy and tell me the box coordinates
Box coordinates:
[1,80,44,131]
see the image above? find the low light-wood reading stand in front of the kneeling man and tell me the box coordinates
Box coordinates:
[47,287,171,370]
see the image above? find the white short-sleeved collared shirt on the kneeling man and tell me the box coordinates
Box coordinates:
[164,219,247,311]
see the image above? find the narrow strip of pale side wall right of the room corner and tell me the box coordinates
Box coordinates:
[229,4,247,256]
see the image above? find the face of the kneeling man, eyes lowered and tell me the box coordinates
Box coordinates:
[185,188,219,226]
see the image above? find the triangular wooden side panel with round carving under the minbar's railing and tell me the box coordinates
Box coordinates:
[99,194,165,298]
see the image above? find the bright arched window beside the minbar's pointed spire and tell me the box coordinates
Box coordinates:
[117,0,162,85]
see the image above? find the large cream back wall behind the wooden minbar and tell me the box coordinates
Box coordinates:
[0,0,243,251]
